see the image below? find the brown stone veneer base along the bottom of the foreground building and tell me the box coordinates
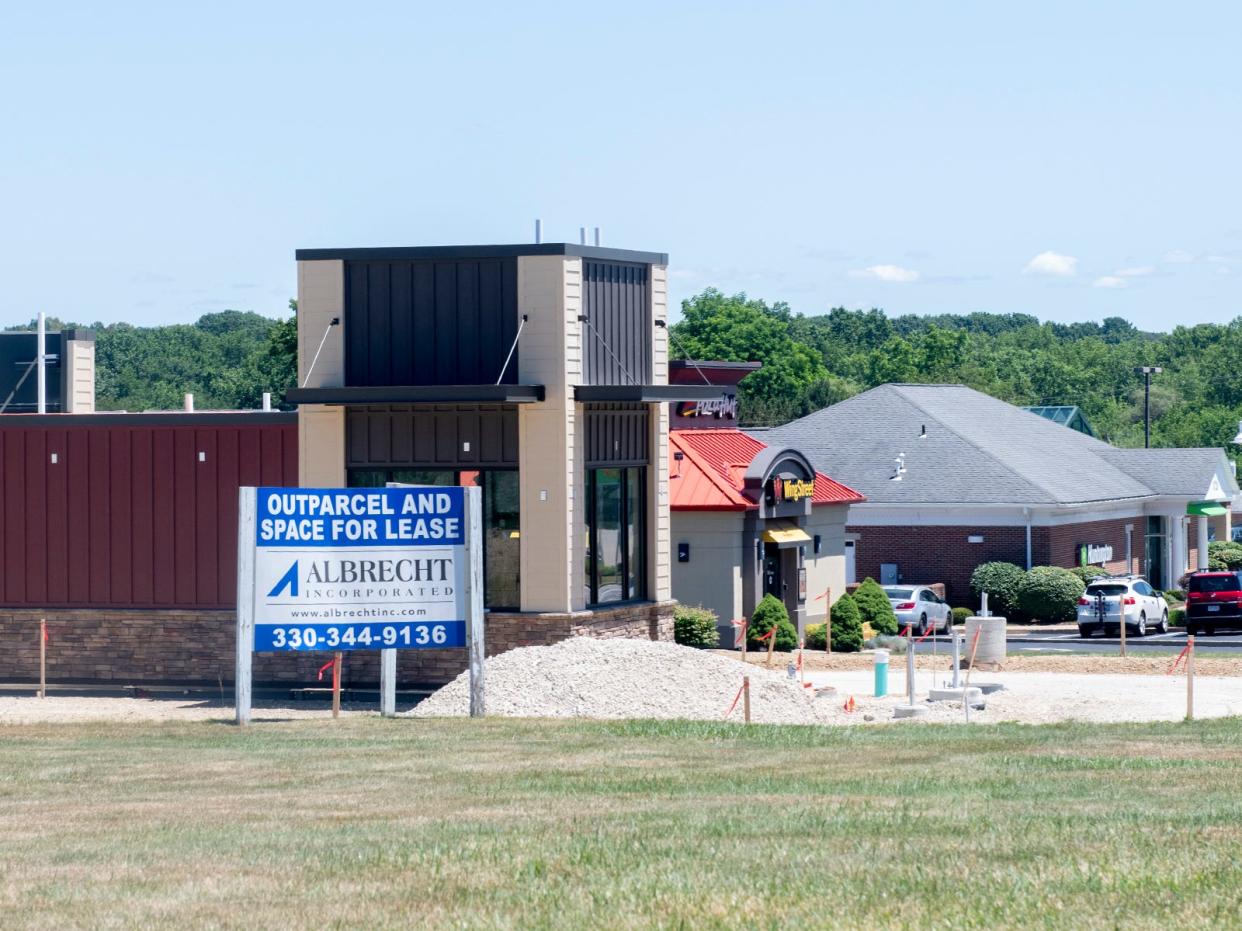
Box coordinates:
[0,602,673,686]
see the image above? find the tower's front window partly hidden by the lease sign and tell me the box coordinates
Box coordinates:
[349,469,522,611]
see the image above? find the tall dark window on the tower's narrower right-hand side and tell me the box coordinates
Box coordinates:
[584,468,647,605]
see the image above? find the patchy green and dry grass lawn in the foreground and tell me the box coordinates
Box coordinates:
[0,719,1242,930]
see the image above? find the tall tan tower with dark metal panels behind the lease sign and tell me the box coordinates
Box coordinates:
[288,243,720,679]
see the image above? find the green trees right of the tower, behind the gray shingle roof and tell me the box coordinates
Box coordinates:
[672,288,1242,454]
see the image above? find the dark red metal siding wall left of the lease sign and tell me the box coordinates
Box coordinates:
[0,425,298,608]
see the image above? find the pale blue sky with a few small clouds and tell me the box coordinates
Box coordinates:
[0,1,1242,329]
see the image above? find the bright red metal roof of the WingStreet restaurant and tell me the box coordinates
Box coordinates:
[668,430,864,510]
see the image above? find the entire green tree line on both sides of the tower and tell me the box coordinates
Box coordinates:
[15,288,1242,454]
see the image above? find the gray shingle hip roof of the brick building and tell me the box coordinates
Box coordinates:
[764,385,1236,505]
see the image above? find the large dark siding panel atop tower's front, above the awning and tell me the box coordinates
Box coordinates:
[345,258,518,386]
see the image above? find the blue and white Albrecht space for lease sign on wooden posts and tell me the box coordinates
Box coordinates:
[237,487,483,724]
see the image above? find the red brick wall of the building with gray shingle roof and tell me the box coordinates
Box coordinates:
[847,518,1157,607]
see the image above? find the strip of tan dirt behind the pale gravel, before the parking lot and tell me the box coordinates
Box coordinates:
[714,644,1242,677]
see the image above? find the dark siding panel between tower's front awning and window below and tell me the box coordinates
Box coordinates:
[345,405,518,469]
